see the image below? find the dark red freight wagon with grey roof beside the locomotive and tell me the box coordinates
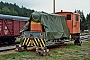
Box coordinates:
[0,14,29,44]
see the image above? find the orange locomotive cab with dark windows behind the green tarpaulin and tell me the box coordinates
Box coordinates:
[55,11,80,40]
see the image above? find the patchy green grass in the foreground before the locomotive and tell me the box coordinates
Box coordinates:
[0,40,90,60]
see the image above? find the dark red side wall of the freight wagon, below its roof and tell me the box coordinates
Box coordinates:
[0,19,26,37]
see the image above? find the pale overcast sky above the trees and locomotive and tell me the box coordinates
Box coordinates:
[0,0,90,15]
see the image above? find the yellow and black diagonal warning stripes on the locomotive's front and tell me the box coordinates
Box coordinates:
[23,38,46,47]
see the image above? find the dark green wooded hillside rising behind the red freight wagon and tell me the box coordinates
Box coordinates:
[0,1,34,17]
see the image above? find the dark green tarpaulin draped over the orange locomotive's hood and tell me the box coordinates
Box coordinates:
[20,12,70,39]
